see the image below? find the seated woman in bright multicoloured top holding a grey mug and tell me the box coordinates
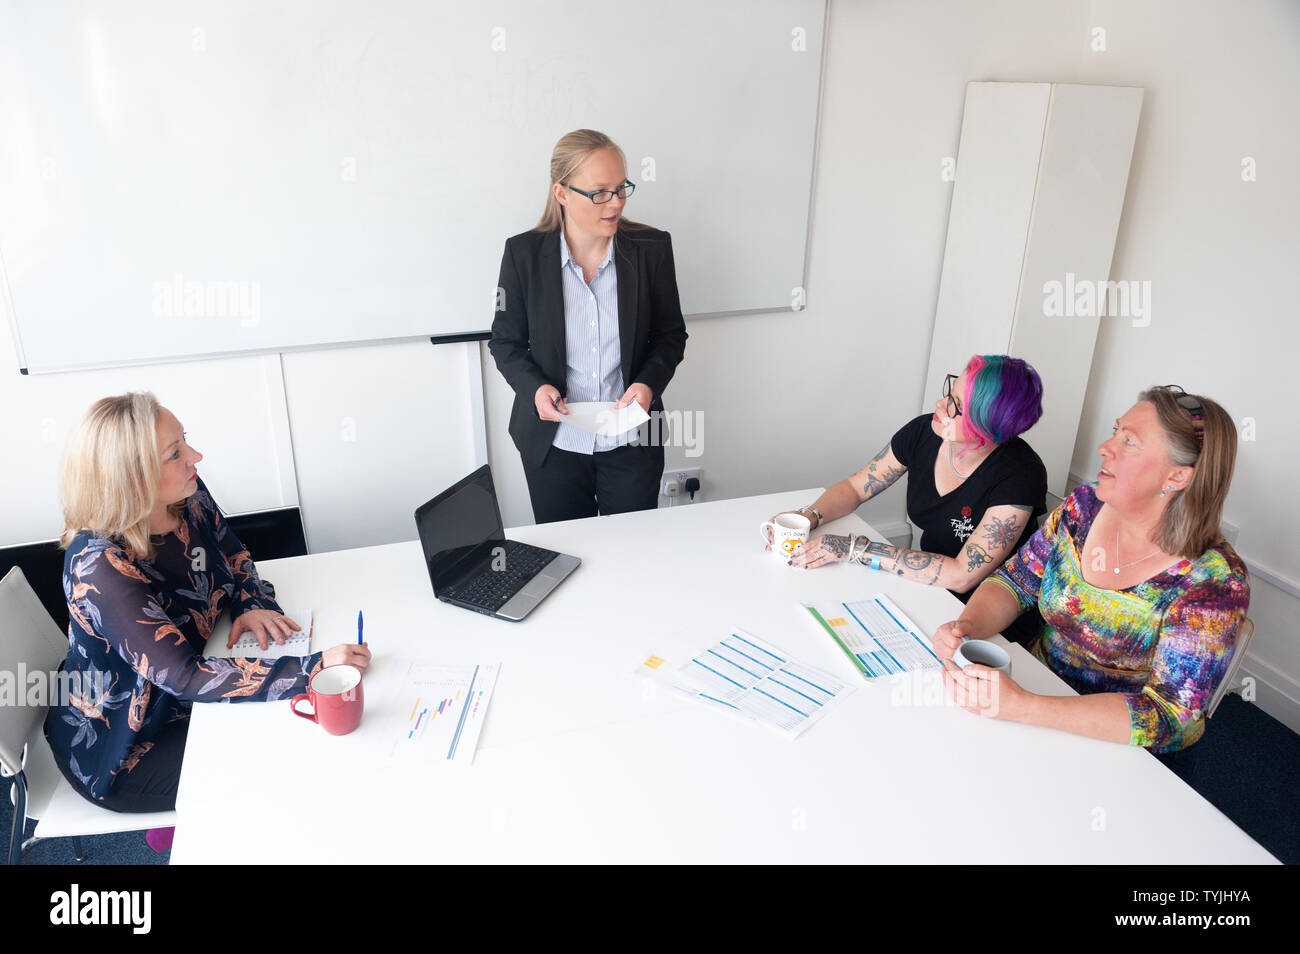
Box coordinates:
[935,386,1251,753]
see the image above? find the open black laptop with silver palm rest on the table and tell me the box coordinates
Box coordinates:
[415,465,582,623]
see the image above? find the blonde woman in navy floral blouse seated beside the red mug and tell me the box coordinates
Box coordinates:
[46,394,371,816]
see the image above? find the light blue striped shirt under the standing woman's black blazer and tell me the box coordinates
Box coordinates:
[551,229,636,454]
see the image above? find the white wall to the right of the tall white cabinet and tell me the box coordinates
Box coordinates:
[1071,0,1300,730]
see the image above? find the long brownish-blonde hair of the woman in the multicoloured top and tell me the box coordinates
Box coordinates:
[1138,386,1236,560]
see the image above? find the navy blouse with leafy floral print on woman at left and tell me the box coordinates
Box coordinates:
[46,480,321,798]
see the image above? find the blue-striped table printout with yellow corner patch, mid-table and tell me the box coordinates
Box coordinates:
[638,629,853,738]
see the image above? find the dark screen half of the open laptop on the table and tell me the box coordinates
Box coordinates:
[415,465,506,594]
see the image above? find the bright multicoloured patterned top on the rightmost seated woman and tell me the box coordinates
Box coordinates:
[989,485,1251,753]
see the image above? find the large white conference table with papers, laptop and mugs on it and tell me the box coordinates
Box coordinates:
[172,490,1275,864]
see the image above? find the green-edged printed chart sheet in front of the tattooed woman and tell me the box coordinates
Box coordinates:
[803,594,944,678]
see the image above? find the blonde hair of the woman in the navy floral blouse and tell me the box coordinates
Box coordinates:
[59,391,185,560]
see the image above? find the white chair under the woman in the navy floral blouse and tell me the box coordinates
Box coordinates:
[0,567,176,864]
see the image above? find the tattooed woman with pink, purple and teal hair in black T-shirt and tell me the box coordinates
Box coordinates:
[774,355,1048,639]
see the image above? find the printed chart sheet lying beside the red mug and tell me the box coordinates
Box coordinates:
[389,663,501,764]
